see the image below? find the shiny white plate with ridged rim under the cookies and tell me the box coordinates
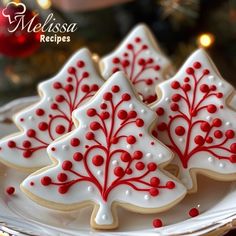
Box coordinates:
[0,97,236,236]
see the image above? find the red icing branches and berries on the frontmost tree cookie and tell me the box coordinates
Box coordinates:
[41,85,175,201]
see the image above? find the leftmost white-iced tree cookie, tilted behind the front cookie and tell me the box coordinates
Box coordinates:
[0,49,103,171]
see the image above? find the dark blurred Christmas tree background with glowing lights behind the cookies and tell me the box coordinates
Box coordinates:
[0,0,236,104]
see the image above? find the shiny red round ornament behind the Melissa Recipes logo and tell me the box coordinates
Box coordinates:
[0,4,42,57]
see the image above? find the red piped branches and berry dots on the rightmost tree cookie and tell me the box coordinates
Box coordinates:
[153,62,236,168]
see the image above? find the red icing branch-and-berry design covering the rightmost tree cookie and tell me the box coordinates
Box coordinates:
[152,61,236,168]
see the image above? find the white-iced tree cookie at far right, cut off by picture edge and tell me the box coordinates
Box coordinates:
[152,50,236,192]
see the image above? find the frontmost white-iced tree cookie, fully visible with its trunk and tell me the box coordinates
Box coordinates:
[21,72,186,229]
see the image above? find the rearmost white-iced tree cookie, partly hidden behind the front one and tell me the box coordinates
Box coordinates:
[100,25,172,103]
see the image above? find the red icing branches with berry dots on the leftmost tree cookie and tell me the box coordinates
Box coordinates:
[8,60,99,158]
